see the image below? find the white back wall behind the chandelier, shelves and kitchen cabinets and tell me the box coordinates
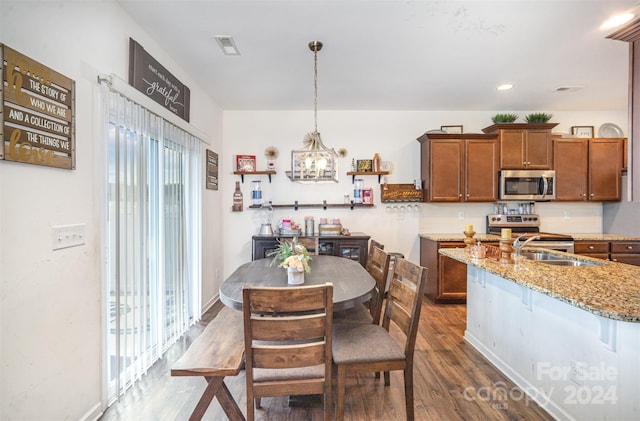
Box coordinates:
[222,108,627,277]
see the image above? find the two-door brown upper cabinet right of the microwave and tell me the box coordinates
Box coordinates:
[553,138,625,201]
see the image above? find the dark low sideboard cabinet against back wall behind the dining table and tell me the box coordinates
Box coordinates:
[251,232,371,267]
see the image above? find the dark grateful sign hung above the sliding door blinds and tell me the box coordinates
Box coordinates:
[129,38,191,121]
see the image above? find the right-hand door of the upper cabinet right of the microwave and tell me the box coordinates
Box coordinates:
[589,138,623,201]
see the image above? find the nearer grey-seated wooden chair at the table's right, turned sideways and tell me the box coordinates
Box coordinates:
[333,258,427,421]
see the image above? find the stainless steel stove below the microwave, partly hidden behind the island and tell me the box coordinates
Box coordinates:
[487,214,574,253]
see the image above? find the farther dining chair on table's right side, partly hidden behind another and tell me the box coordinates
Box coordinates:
[333,247,391,325]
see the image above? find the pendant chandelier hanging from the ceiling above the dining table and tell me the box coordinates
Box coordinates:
[287,41,338,183]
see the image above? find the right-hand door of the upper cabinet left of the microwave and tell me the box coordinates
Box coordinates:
[464,139,498,202]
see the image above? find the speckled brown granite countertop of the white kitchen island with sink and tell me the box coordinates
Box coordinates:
[438,247,640,323]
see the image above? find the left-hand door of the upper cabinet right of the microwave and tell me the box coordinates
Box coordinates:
[553,139,589,201]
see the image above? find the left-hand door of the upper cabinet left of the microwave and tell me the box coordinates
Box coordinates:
[429,140,464,202]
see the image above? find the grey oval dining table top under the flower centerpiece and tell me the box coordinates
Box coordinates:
[220,256,375,311]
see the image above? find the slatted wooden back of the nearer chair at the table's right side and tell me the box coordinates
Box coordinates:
[382,258,427,359]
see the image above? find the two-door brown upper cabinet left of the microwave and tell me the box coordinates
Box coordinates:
[418,133,499,202]
